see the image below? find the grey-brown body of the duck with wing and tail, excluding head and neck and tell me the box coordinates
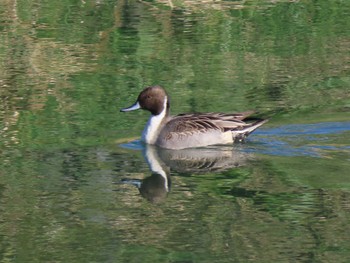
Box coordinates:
[157,113,267,149]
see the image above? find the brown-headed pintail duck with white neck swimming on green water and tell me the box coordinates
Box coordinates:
[120,86,267,149]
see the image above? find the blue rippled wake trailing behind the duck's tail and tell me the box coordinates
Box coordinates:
[246,122,350,157]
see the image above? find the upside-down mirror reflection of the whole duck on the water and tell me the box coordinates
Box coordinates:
[122,145,251,203]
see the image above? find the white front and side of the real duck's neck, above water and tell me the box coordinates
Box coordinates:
[142,97,169,144]
